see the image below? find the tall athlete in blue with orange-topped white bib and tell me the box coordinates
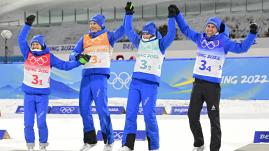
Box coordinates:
[70,14,124,151]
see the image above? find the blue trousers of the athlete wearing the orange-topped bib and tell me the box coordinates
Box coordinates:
[79,75,114,144]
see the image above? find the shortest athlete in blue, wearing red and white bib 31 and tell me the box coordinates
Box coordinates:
[18,15,88,151]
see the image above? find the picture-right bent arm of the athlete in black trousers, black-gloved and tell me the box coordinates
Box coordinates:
[224,23,258,53]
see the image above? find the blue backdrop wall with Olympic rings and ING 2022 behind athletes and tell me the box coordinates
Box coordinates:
[0,57,269,100]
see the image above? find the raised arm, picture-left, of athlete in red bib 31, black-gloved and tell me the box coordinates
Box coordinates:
[18,15,35,60]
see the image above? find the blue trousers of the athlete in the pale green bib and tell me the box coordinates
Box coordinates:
[122,79,159,150]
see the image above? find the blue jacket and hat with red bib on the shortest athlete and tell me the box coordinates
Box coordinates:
[18,25,80,95]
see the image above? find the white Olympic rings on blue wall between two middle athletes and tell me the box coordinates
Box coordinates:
[108,72,131,90]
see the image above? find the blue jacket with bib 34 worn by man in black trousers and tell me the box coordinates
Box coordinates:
[176,13,257,83]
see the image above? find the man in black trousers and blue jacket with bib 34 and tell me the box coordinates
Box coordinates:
[171,5,258,151]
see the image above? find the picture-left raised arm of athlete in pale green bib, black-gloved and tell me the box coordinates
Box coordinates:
[124,2,141,48]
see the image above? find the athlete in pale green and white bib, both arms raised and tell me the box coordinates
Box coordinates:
[119,2,176,151]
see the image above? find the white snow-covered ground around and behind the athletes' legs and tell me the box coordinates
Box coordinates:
[0,98,269,151]
